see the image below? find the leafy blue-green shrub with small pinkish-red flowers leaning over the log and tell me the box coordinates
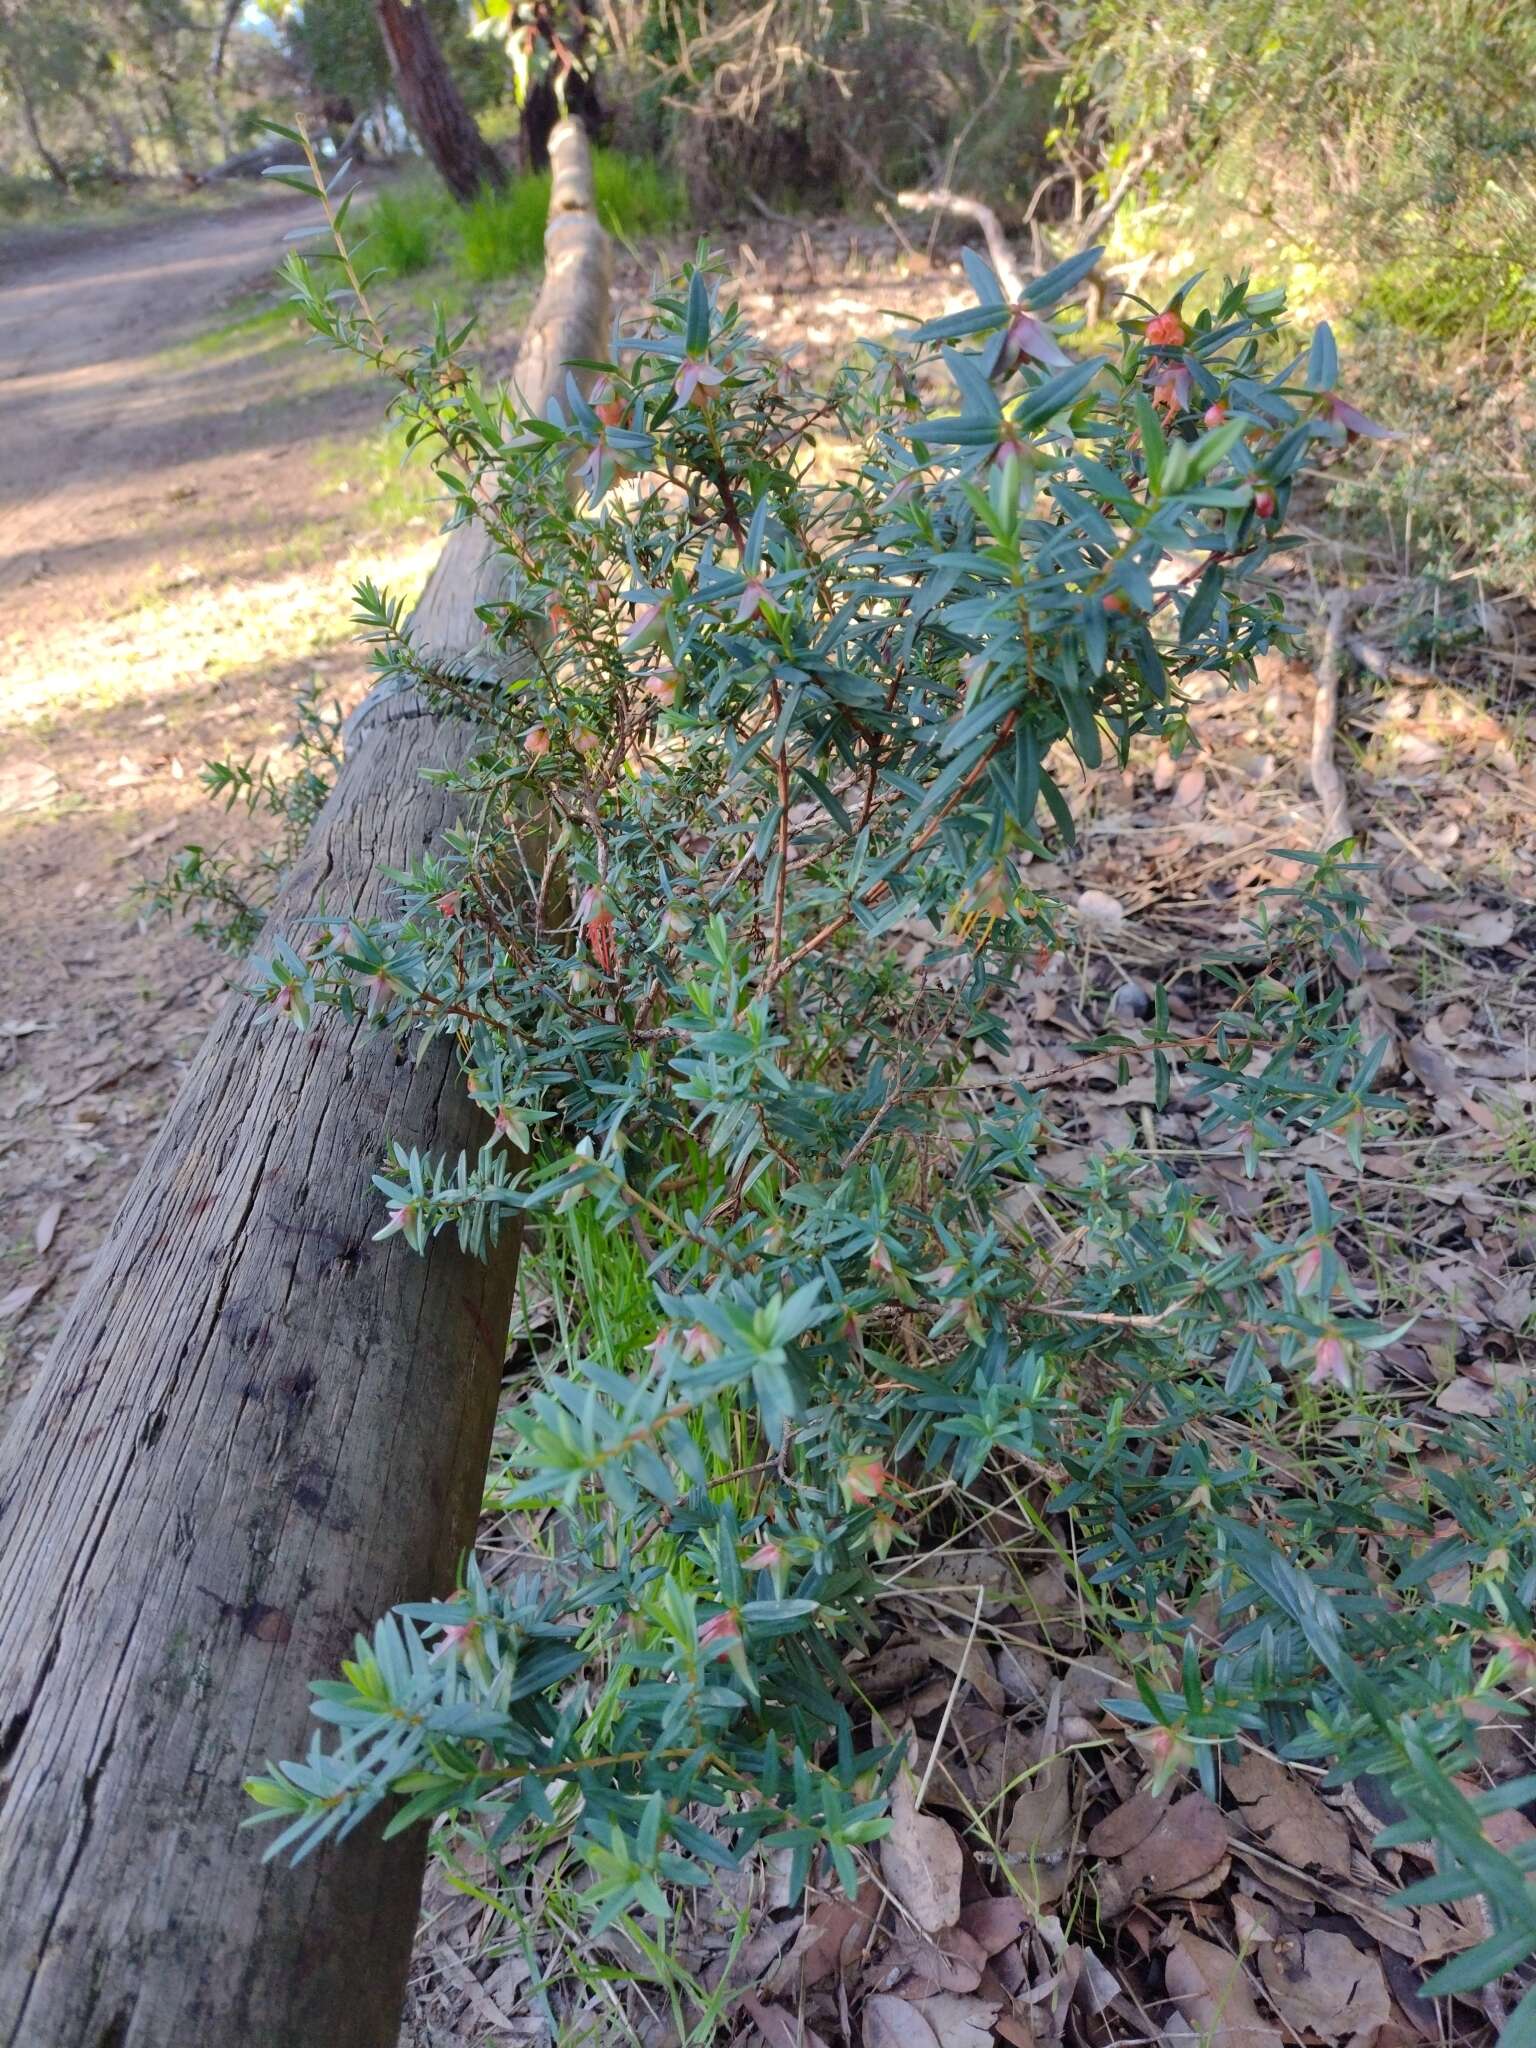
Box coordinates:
[252,144,1536,2015]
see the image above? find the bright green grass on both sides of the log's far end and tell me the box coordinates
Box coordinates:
[362,150,686,285]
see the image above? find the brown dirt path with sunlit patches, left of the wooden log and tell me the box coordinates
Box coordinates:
[0,195,436,1413]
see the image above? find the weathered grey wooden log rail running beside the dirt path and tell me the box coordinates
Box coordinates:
[0,127,606,2048]
